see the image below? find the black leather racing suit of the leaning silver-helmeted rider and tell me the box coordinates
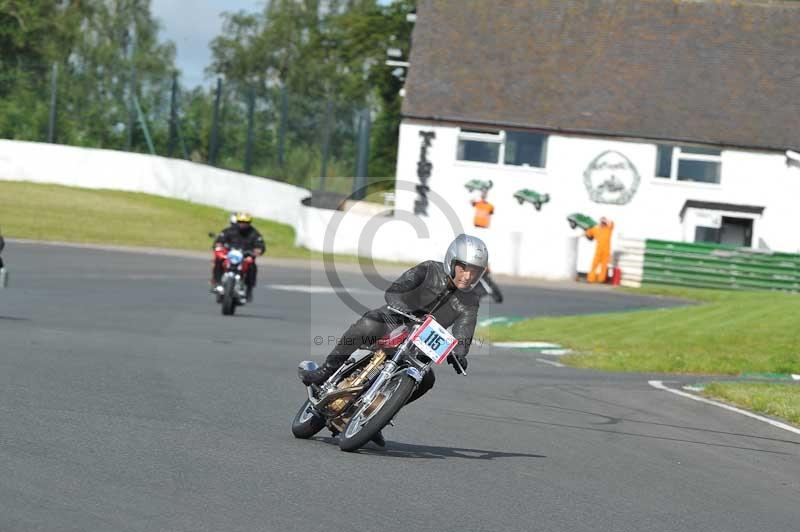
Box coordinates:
[325,261,480,402]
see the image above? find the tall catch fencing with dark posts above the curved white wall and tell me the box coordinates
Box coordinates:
[0,61,385,194]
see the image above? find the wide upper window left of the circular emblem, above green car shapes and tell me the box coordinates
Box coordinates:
[456,129,547,168]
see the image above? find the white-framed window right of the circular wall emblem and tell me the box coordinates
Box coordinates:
[656,144,722,183]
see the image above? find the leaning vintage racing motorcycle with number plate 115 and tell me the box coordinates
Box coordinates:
[292,307,466,452]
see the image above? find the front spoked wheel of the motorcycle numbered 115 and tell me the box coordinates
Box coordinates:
[339,373,416,452]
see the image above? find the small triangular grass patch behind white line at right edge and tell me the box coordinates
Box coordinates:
[702,382,800,426]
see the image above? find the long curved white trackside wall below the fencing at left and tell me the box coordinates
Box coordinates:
[0,140,311,226]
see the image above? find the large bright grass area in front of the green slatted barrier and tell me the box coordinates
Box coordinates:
[482,287,800,375]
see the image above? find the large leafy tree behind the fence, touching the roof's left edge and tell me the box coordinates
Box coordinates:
[207,0,414,186]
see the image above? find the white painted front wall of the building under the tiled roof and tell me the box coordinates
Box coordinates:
[396,121,800,273]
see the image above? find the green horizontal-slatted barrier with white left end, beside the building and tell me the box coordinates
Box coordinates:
[617,239,800,292]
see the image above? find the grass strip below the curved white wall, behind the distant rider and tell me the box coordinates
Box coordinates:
[0,181,310,257]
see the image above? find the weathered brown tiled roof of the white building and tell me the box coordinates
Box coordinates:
[403,0,800,150]
